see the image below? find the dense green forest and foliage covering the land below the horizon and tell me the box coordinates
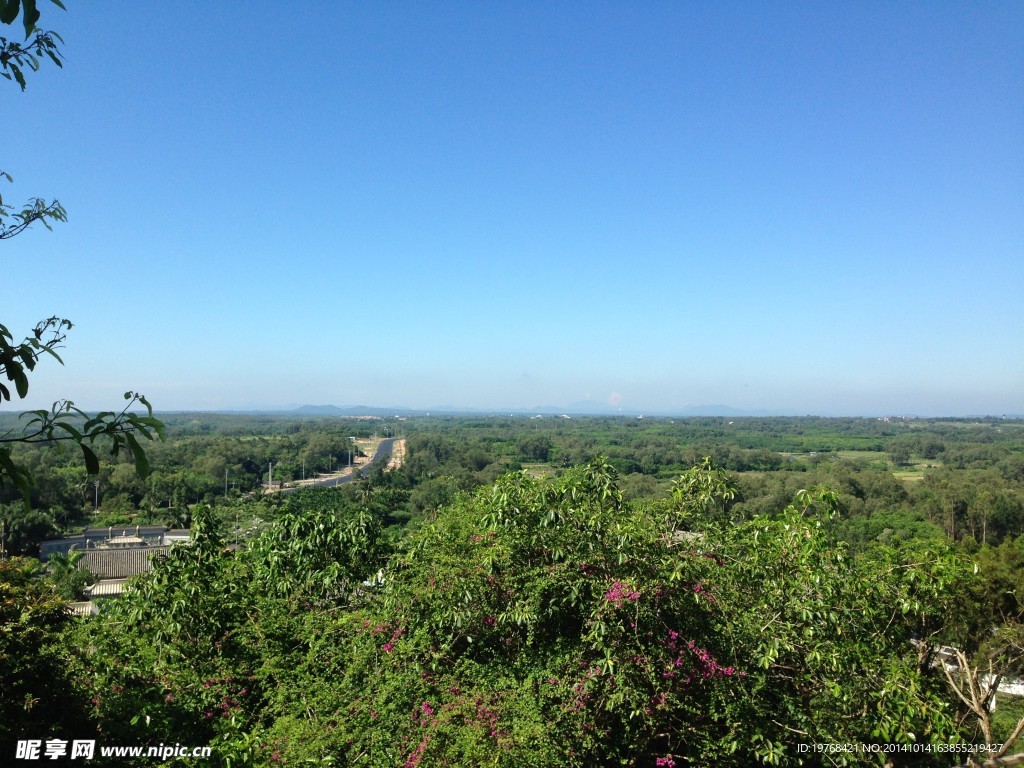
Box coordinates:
[0,414,1024,766]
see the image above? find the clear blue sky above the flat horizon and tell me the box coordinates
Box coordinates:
[0,0,1024,416]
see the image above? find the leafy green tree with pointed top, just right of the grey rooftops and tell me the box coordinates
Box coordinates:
[69,509,252,757]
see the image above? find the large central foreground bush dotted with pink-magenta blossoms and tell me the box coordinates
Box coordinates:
[237,461,733,766]
